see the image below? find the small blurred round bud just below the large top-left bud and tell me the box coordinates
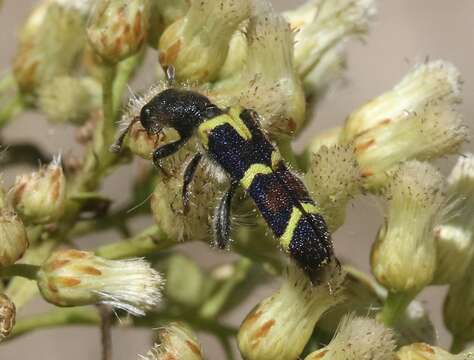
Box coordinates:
[38,76,101,125]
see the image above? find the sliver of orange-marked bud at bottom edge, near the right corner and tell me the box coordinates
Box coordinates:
[397,343,466,360]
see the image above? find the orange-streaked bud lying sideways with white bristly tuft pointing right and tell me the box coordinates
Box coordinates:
[38,250,163,316]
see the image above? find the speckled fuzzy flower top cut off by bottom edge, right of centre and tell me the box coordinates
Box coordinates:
[305,315,395,360]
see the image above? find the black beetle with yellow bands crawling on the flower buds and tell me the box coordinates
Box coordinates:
[113,67,337,283]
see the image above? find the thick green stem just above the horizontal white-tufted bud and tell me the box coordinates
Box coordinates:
[95,225,176,259]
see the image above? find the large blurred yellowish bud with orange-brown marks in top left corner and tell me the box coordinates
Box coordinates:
[13,1,87,93]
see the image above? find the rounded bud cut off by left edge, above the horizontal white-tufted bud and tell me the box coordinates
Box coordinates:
[0,208,29,267]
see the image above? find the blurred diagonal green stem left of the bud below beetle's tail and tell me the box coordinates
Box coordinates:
[199,258,252,319]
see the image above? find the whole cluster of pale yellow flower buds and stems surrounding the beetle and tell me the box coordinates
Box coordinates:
[0,0,474,360]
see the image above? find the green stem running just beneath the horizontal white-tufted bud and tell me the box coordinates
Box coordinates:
[9,307,100,340]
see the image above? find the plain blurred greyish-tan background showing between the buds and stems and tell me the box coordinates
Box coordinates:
[0,0,474,360]
